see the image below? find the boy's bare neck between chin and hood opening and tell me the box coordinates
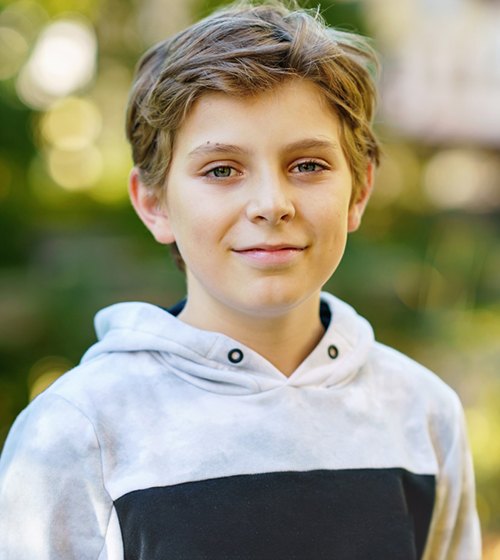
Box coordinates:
[178,294,324,376]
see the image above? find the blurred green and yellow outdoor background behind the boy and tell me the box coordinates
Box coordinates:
[0,0,500,560]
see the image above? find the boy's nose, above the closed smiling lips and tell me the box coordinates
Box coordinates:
[246,175,295,225]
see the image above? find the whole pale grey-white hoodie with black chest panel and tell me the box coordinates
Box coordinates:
[0,293,481,560]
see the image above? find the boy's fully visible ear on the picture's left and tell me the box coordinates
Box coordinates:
[128,167,175,245]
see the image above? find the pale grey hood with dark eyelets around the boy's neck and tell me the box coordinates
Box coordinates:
[82,292,374,395]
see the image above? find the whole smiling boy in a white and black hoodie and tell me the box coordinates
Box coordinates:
[0,3,480,560]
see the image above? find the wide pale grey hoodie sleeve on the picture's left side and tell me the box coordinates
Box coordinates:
[0,394,118,560]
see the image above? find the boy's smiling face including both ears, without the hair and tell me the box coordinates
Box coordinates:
[131,80,371,322]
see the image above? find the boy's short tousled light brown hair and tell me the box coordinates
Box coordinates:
[126,0,380,266]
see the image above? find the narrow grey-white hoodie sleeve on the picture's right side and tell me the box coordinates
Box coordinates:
[424,397,481,560]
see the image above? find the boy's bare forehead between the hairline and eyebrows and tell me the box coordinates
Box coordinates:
[175,79,339,152]
